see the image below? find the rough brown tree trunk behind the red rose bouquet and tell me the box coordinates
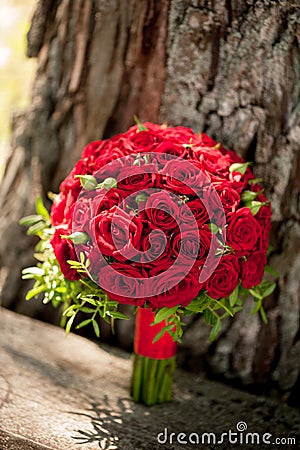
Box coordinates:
[0,0,300,401]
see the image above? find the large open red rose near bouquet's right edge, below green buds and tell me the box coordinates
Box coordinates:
[226,207,261,255]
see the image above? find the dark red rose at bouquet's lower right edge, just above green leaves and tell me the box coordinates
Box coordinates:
[241,251,267,289]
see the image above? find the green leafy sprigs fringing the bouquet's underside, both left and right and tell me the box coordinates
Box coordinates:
[20,198,278,342]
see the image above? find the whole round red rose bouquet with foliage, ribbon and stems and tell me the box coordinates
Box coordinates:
[21,121,275,405]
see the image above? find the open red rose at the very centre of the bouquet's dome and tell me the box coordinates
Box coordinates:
[144,191,179,230]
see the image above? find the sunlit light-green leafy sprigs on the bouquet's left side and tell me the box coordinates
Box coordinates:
[20,198,128,337]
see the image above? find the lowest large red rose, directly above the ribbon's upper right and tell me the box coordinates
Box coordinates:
[148,267,201,308]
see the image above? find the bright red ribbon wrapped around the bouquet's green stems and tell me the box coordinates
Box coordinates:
[134,307,178,359]
